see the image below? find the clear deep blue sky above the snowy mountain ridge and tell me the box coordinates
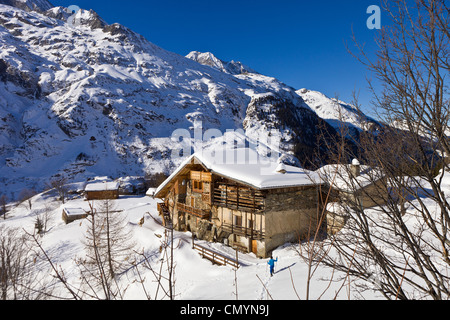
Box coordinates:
[50,0,384,111]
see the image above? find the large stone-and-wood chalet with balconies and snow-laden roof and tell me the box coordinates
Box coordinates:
[154,149,321,258]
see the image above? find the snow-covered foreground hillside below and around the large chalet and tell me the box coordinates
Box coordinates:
[0,164,450,301]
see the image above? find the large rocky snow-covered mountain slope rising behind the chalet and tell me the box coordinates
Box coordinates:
[0,0,372,198]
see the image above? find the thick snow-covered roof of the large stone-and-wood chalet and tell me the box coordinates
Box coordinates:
[155,149,320,197]
